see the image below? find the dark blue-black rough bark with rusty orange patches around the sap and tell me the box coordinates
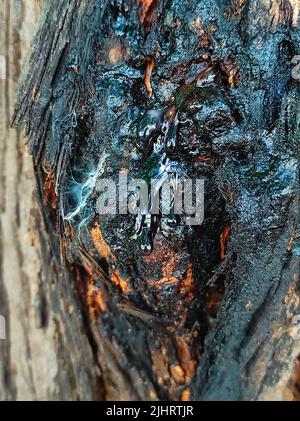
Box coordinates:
[2,0,300,400]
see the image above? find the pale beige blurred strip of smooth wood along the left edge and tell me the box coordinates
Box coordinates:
[0,0,102,400]
